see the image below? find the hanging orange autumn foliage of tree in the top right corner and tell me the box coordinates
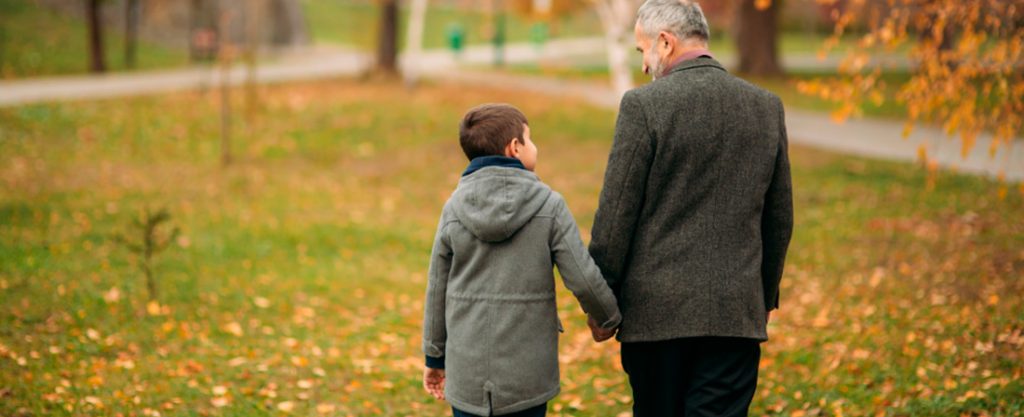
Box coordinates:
[798,0,1024,172]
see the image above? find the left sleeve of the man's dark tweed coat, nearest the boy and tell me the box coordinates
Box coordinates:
[590,90,654,293]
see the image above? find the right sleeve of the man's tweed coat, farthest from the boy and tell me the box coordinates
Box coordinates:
[761,102,793,311]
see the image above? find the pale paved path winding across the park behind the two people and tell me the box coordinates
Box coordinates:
[0,38,1024,182]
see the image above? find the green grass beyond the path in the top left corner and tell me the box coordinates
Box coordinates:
[0,0,187,79]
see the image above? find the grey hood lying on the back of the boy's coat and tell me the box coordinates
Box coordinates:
[451,166,551,243]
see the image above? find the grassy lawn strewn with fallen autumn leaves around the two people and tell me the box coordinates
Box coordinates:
[0,80,1024,416]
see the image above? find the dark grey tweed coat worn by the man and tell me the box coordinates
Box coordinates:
[590,57,793,342]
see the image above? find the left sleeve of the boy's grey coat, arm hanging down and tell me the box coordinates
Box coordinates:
[423,214,452,369]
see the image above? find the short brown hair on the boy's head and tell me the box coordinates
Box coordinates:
[459,103,529,161]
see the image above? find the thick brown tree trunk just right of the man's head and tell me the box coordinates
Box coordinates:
[736,0,782,76]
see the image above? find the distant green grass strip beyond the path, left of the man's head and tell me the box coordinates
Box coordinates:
[303,0,602,50]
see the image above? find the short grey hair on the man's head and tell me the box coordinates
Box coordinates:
[637,0,711,42]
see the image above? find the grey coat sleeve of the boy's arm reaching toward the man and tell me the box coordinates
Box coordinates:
[551,194,623,329]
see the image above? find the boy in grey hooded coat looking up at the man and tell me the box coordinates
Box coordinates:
[423,105,622,417]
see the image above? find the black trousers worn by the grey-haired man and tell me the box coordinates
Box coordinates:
[622,337,761,417]
